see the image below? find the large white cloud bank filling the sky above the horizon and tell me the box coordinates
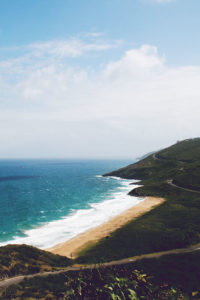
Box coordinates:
[0,42,200,157]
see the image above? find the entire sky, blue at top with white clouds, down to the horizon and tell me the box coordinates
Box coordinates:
[0,0,200,159]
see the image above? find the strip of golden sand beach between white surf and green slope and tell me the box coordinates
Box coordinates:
[46,197,165,258]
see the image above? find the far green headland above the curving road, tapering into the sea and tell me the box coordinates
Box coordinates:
[105,138,200,190]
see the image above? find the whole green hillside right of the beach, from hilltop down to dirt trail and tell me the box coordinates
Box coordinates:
[78,139,200,262]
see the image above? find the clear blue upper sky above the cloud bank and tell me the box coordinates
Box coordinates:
[0,0,200,64]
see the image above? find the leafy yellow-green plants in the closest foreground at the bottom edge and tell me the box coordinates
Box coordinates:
[63,269,184,300]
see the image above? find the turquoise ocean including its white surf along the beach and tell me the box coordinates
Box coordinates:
[0,160,143,249]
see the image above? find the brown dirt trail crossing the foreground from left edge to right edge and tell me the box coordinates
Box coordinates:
[0,243,200,290]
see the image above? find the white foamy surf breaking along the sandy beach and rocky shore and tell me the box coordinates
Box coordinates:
[0,175,144,249]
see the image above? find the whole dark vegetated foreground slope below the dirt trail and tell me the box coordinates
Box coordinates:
[1,251,200,300]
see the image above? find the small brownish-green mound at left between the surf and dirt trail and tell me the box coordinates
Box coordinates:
[0,245,71,277]
